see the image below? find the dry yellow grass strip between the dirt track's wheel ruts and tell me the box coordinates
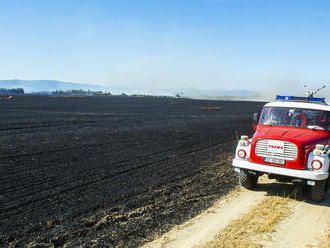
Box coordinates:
[198,196,291,248]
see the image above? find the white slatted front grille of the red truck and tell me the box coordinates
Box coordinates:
[255,139,298,161]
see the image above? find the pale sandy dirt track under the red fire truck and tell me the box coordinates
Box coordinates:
[143,174,330,248]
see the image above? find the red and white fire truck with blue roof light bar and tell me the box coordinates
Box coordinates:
[232,96,330,201]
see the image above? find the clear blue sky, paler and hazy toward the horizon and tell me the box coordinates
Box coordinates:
[0,0,330,91]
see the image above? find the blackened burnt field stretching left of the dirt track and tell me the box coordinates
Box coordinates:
[0,96,263,247]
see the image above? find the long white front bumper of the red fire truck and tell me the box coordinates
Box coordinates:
[233,158,329,181]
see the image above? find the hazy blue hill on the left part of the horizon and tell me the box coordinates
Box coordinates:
[0,79,106,93]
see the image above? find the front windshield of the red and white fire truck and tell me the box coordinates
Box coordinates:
[259,107,330,130]
